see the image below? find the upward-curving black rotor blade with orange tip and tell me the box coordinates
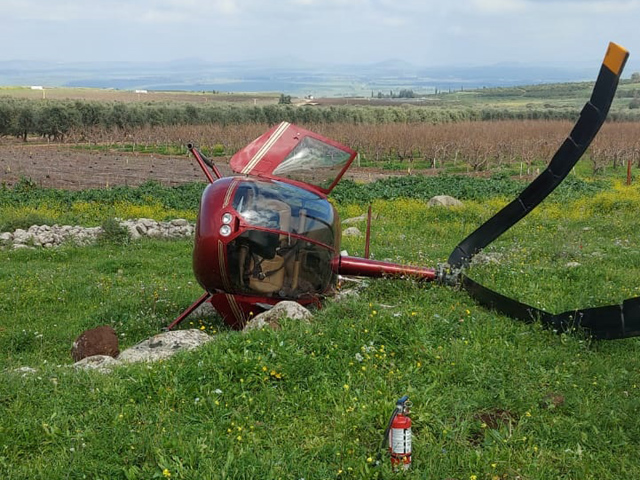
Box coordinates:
[448,43,629,268]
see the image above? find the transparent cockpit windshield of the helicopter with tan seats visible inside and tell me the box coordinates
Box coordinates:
[227,179,340,299]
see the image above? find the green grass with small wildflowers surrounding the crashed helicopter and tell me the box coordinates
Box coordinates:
[0,185,640,480]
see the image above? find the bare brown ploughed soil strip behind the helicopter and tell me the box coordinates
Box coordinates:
[0,144,404,190]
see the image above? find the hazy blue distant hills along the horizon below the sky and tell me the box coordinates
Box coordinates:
[0,58,637,96]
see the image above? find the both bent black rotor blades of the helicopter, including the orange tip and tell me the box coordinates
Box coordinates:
[448,43,640,339]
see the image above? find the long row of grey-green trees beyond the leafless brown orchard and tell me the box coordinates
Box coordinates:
[0,97,638,141]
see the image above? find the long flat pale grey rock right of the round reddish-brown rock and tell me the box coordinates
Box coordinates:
[118,329,213,363]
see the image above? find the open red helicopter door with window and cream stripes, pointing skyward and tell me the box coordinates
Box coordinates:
[230,122,357,195]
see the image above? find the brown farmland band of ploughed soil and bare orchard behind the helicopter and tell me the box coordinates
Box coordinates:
[0,120,640,189]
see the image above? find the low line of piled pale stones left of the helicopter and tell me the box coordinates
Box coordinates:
[0,218,195,248]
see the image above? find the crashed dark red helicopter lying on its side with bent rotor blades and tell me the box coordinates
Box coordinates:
[167,43,640,338]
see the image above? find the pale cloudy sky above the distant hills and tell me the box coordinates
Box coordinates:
[0,0,640,66]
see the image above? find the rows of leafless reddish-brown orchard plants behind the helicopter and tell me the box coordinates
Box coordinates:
[69,120,640,173]
